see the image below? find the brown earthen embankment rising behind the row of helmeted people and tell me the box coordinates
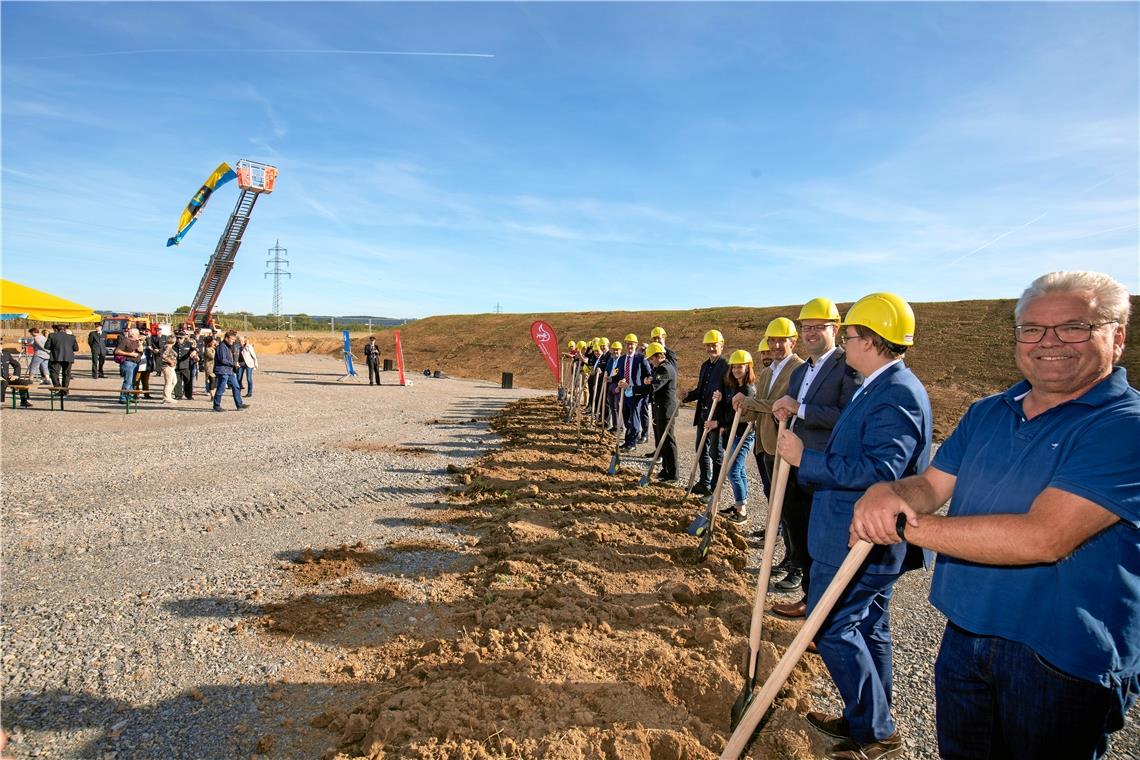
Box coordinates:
[263,297,1140,438]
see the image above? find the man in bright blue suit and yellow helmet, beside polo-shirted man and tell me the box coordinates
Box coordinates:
[776,293,933,760]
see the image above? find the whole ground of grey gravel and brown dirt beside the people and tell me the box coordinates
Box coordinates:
[0,350,1140,760]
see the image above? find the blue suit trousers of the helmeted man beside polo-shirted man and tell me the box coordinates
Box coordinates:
[807,562,898,744]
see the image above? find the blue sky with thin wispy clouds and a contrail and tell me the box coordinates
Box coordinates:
[0,2,1140,317]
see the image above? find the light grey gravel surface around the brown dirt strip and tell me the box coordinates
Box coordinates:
[0,356,1140,760]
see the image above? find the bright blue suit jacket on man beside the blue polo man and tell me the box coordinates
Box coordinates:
[799,362,934,573]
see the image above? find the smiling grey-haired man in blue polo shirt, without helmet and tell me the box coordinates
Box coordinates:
[850,272,1140,760]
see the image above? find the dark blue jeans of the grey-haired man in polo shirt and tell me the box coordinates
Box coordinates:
[935,623,1121,760]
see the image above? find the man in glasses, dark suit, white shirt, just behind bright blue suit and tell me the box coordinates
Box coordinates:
[772,299,856,618]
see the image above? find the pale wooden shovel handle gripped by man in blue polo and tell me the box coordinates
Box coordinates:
[720,541,874,760]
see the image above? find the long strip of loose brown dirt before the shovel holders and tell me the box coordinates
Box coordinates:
[251,398,827,760]
